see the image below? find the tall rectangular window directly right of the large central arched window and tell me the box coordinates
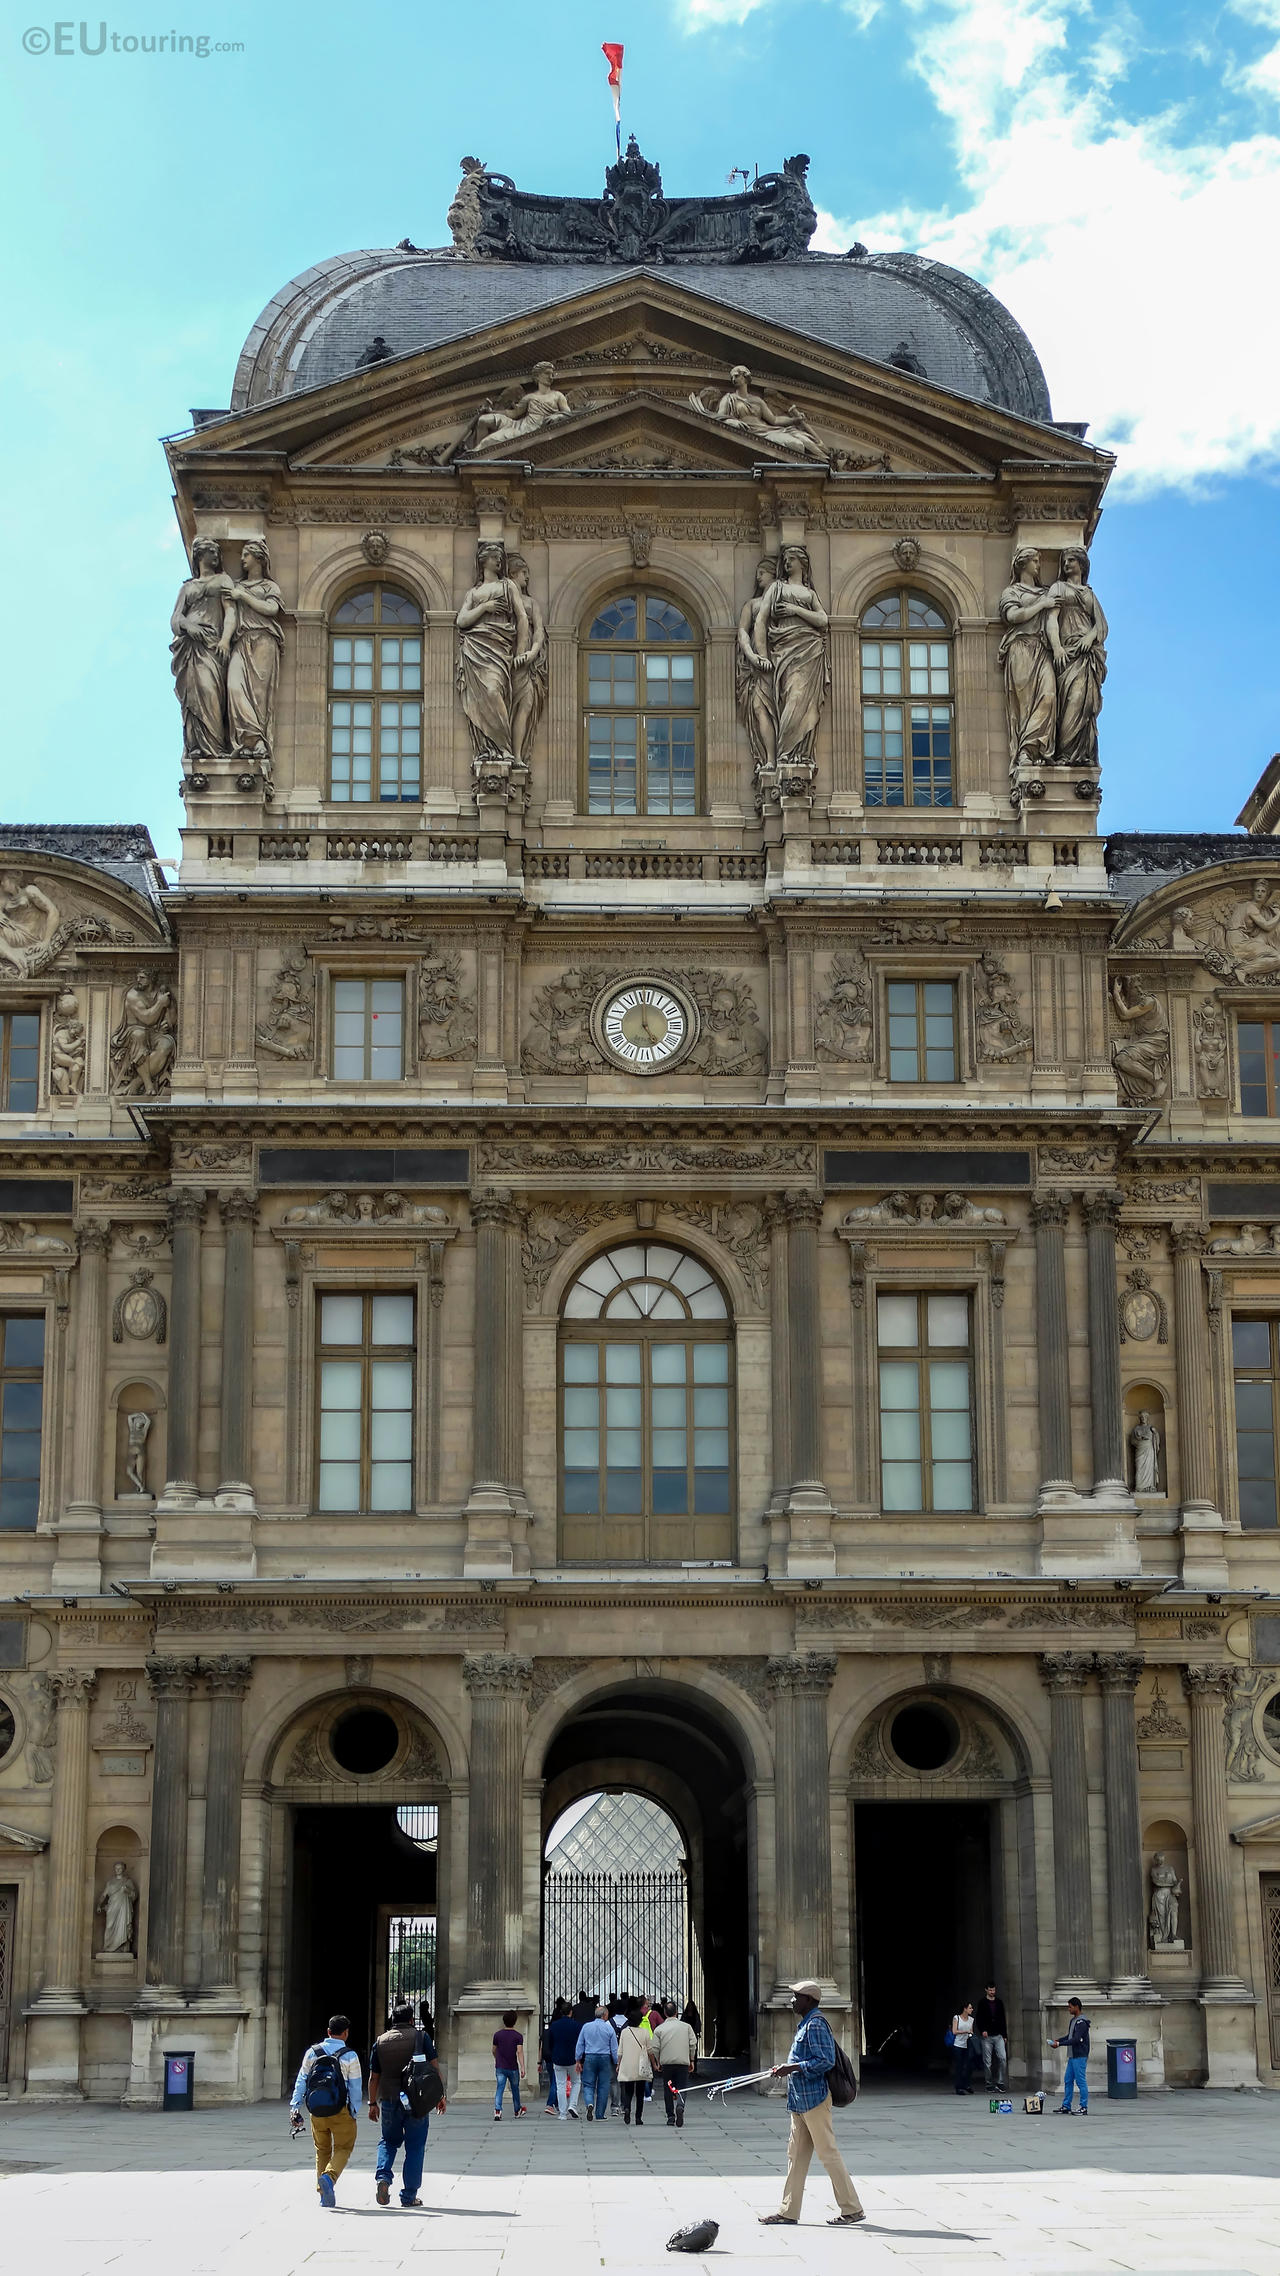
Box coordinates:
[877,1295,977,1511]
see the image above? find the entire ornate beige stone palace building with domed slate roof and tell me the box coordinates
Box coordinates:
[0,137,1280,2105]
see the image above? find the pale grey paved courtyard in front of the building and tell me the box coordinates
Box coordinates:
[0,2087,1280,2276]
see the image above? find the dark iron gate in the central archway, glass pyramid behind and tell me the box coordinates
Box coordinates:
[542,1871,704,2012]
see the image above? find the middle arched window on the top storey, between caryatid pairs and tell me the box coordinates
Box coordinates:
[583,589,701,815]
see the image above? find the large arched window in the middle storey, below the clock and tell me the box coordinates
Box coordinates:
[560,1240,733,1564]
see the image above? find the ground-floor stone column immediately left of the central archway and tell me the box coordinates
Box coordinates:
[462,1652,533,2007]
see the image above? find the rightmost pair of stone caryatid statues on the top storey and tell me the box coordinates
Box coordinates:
[1000,546,1107,778]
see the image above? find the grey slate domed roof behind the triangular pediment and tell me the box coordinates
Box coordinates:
[230,246,1052,423]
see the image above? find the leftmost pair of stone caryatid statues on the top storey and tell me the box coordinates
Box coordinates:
[169,537,285,783]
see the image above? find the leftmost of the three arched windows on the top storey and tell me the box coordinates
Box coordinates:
[328,585,421,806]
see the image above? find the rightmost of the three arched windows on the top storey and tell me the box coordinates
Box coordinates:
[863,592,954,806]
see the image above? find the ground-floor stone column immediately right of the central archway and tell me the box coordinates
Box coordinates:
[765,1652,836,1998]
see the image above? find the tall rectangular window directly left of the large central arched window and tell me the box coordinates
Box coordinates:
[317,1290,415,1511]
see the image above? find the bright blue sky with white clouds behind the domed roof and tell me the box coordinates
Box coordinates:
[0,0,1280,854]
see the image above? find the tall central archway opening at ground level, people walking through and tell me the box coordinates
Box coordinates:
[542,1677,756,2058]
